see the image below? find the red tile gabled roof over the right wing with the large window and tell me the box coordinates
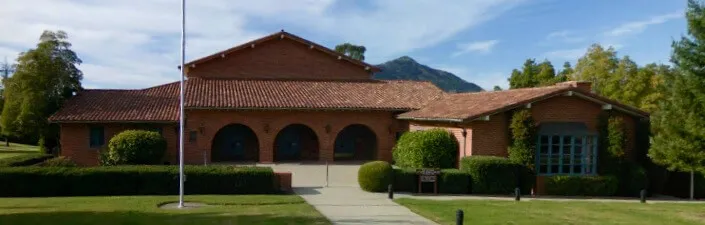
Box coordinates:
[397,85,649,122]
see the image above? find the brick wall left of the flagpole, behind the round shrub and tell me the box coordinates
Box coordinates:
[59,123,178,166]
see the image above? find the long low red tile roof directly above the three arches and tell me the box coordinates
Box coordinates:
[49,78,444,122]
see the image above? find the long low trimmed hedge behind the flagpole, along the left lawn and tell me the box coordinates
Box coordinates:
[0,166,276,197]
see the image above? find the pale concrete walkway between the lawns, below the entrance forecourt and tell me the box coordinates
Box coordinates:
[294,187,436,225]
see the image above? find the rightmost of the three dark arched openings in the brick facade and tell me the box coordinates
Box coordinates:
[335,124,377,160]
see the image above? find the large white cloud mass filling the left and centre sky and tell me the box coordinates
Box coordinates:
[0,0,523,88]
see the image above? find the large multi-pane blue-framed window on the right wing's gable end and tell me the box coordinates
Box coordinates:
[536,123,597,175]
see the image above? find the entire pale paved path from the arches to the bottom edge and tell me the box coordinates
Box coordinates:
[261,163,436,225]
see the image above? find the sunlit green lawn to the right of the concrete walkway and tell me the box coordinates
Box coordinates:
[395,198,705,225]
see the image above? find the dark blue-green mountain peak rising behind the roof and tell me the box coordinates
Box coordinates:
[374,56,482,92]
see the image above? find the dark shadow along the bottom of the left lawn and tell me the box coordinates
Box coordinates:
[0,211,329,225]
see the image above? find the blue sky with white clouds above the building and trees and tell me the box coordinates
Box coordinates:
[0,0,686,90]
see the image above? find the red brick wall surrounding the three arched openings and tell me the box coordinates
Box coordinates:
[184,110,406,164]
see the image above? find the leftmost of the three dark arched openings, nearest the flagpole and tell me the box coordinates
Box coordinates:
[211,124,259,162]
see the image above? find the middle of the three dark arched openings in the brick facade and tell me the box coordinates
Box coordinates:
[274,124,318,161]
